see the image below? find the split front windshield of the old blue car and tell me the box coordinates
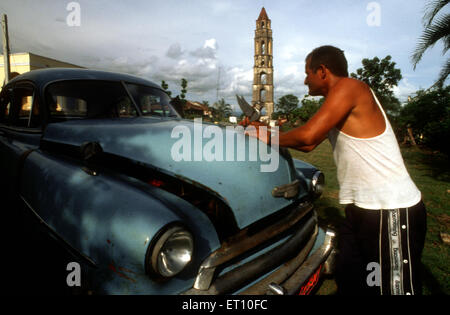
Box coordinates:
[46,80,177,121]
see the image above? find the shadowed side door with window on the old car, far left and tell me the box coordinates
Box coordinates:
[0,82,42,204]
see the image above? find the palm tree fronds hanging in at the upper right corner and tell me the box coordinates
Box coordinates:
[411,0,450,87]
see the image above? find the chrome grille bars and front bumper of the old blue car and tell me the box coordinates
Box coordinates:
[182,205,334,295]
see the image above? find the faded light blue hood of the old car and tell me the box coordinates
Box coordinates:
[43,117,306,228]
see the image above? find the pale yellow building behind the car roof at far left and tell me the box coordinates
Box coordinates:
[0,52,83,87]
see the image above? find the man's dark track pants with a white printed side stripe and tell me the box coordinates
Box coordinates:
[336,201,426,295]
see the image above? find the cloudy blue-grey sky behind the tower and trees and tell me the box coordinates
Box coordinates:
[0,0,449,110]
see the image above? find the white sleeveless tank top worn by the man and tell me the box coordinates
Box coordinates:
[328,90,421,209]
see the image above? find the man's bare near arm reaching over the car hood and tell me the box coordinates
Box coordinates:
[279,79,354,152]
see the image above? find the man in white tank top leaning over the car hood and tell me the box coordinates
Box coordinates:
[253,46,426,294]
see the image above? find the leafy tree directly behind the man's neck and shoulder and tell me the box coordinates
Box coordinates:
[351,55,402,117]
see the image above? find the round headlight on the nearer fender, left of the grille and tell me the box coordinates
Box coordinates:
[150,226,194,277]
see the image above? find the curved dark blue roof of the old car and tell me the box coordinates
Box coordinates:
[8,68,161,89]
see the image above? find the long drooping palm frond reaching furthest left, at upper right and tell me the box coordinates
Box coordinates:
[411,14,450,69]
